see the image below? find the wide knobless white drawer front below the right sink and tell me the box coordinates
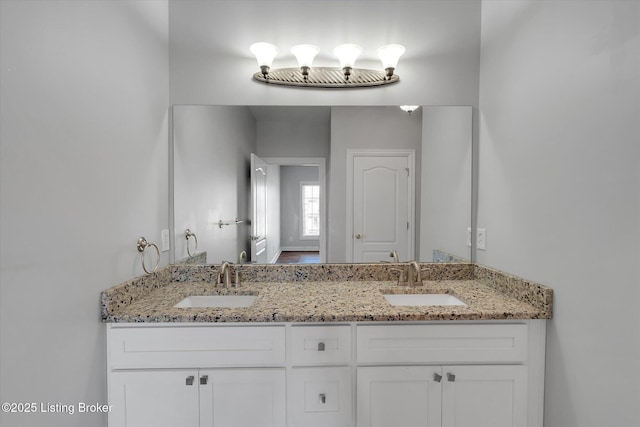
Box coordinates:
[357,324,527,364]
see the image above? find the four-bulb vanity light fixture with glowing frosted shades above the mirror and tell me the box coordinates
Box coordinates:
[249,42,405,88]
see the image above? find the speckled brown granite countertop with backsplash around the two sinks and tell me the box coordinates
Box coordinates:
[101,263,552,322]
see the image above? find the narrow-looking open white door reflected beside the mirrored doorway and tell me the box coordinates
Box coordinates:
[249,153,267,264]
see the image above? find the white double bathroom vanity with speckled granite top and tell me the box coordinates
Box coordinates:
[102,264,552,427]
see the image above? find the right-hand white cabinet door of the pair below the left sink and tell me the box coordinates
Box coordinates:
[199,369,286,427]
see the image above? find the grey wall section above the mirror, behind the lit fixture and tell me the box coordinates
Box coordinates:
[169,0,480,106]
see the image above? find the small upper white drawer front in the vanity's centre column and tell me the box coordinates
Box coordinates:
[291,325,351,366]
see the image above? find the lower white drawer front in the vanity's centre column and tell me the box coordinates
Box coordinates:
[288,367,353,427]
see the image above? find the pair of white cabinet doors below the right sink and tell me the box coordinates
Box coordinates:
[357,365,527,427]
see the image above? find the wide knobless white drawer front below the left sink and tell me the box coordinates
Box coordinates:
[107,326,285,369]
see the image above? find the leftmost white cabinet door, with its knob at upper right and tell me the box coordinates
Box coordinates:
[109,371,199,427]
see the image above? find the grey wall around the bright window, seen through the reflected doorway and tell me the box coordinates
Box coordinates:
[280,166,320,250]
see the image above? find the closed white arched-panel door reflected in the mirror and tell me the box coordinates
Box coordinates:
[352,155,413,262]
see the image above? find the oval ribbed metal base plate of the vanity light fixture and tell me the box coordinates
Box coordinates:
[253,67,400,88]
